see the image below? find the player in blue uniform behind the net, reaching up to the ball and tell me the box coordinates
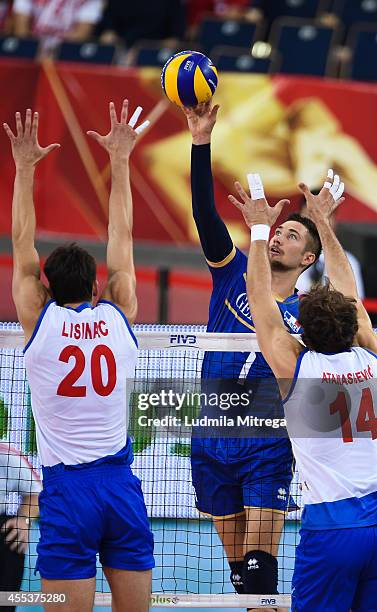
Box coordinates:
[185,104,321,608]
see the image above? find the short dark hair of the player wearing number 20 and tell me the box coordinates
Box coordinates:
[44,242,96,306]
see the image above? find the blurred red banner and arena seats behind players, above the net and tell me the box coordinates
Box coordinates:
[0,0,377,324]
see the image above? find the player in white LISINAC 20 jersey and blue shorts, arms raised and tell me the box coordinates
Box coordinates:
[4,100,154,612]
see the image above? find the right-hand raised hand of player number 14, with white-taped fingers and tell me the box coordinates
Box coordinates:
[298,168,345,223]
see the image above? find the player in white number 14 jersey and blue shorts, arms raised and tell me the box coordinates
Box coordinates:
[231,170,377,612]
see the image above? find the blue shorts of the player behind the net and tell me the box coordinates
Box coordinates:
[191,437,293,518]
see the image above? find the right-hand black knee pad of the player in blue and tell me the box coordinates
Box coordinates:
[242,550,278,595]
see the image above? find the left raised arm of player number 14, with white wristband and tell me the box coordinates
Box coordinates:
[229,175,302,379]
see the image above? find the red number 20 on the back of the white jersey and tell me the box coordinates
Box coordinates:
[56,344,117,397]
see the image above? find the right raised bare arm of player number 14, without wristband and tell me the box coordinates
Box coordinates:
[299,169,377,352]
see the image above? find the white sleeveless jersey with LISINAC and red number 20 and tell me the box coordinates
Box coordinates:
[24,300,137,466]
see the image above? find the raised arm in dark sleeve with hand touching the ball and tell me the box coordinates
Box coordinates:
[184,102,235,265]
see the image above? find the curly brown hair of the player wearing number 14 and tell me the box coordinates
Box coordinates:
[298,281,358,353]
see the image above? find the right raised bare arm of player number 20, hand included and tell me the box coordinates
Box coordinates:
[88,100,149,323]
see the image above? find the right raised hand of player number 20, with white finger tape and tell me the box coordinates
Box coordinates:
[87,100,150,160]
